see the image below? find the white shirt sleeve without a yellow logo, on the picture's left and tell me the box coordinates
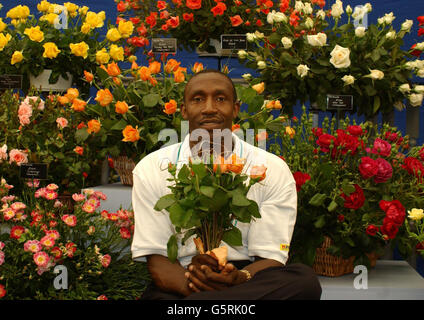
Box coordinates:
[131,162,174,261]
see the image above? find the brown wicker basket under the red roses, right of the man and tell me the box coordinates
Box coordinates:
[312,237,377,277]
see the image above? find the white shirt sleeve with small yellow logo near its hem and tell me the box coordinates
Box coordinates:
[248,159,297,264]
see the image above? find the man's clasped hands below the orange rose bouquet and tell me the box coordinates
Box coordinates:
[185,263,247,292]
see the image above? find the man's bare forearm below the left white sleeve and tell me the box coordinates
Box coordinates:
[147,254,193,296]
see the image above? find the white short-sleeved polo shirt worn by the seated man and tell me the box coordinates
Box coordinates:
[131,134,297,267]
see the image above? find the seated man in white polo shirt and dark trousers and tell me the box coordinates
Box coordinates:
[131,70,321,300]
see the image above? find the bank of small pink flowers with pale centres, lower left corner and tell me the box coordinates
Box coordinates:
[0,180,149,300]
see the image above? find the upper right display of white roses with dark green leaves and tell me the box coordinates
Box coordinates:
[239,0,424,118]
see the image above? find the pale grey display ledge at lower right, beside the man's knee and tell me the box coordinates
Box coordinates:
[319,260,424,300]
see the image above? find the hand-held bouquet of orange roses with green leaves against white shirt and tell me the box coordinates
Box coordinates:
[155,154,266,266]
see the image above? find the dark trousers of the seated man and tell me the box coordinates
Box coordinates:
[141,262,322,300]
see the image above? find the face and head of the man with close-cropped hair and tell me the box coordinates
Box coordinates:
[181,73,240,137]
